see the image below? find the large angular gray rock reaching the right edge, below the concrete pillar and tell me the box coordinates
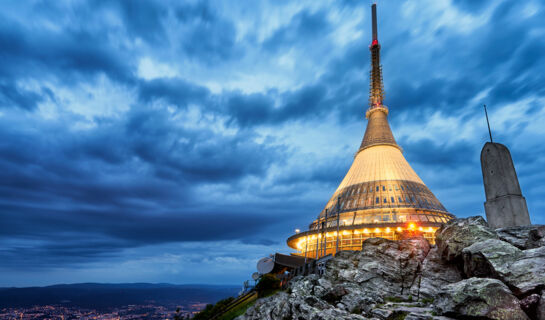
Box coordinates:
[463,239,545,296]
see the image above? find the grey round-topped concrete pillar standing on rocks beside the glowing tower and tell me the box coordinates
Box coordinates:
[481,142,531,228]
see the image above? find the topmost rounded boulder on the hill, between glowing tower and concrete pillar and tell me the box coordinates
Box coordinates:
[435,216,498,262]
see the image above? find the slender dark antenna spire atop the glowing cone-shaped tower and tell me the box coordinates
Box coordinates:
[369,3,384,108]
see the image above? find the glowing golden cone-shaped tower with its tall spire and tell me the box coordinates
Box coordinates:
[287,4,454,258]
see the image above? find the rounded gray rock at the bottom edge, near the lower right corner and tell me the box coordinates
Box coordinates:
[436,278,529,320]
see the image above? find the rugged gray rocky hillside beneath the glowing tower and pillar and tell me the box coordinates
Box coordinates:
[237,217,545,320]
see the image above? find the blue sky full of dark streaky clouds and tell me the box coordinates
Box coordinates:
[0,0,545,286]
